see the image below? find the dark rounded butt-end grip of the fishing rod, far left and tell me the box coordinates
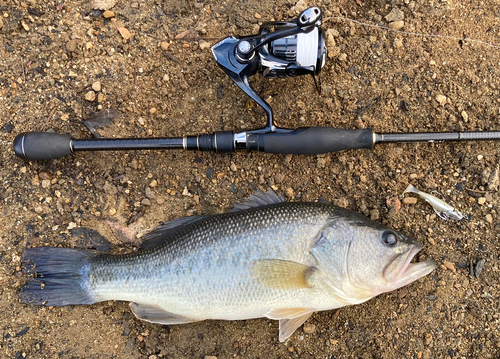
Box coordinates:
[14,132,73,161]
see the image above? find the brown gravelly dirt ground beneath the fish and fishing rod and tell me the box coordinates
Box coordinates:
[0,0,500,359]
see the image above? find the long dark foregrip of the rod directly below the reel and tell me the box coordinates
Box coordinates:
[247,127,374,155]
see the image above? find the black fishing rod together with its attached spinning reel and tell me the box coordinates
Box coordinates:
[10,7,500,160]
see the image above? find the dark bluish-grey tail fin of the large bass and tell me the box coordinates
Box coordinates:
[20,247,96,306]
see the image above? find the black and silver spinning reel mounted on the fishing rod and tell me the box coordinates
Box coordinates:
[212,7,327,132]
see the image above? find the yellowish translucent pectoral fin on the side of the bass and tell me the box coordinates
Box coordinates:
[251,259,316,289]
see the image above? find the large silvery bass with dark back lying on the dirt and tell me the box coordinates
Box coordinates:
[20,190,436,342]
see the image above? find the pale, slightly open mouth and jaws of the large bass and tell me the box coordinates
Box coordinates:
[384,246,436,291]
